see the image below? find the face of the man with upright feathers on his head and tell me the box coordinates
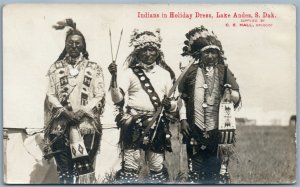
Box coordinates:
[66,35,84,58]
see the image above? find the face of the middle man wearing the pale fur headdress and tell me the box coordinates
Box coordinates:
[138,47,159,65]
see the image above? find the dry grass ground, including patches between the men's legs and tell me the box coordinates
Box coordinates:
[100,122,296,184]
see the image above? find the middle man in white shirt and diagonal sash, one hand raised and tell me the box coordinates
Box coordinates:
[109,30,176,183]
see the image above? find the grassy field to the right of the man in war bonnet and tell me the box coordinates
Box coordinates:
[231,126,296,184]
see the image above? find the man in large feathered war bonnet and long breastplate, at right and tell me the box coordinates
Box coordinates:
[178,26,241,184]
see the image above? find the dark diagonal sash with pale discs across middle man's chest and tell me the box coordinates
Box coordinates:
[131,66,161,110]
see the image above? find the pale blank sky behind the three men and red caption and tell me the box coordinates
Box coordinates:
[3,4,296,128]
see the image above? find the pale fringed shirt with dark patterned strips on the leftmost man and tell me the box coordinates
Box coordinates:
[45,56,105,134]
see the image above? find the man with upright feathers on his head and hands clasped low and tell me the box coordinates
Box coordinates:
[45,19,105,184]
